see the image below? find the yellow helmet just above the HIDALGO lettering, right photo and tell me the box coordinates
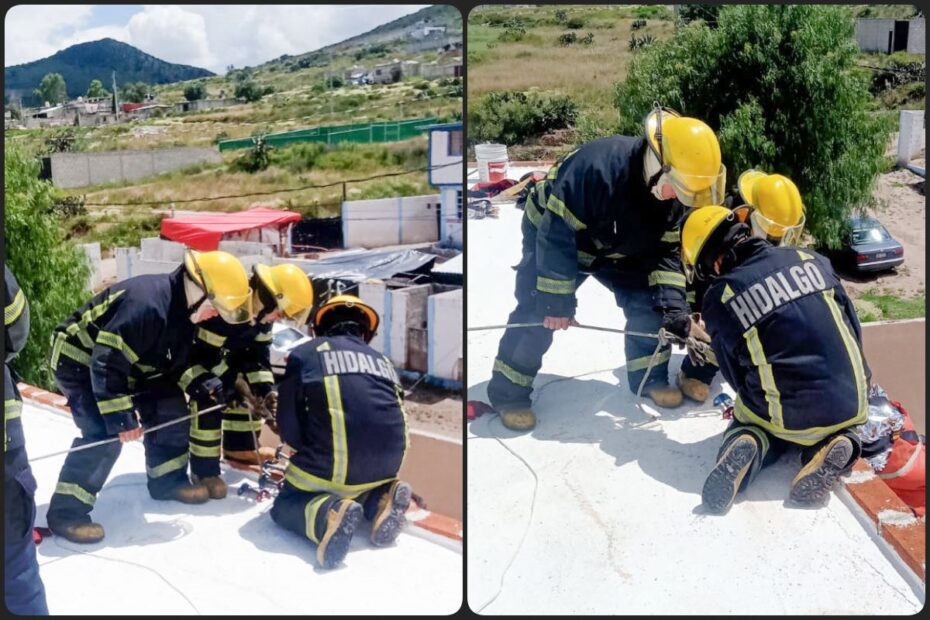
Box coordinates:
[737,170,804,245]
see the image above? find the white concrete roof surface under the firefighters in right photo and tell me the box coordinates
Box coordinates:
[466,168,924,615]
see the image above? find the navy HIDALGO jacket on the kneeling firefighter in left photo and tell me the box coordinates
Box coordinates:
[277,336,407,498]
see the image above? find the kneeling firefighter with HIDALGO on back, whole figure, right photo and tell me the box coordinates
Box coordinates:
[681,206,871,513]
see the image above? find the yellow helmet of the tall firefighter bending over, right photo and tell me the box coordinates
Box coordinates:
[643,104,727,207]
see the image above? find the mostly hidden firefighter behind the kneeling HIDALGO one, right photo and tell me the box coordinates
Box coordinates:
[678,170,804,402]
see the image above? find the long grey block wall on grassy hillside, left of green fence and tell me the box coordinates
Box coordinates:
[50,147,222,188]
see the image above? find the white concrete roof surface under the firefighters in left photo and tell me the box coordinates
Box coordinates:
[23,402,462,615]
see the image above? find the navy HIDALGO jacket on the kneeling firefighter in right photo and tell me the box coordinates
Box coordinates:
[703,239,871,446]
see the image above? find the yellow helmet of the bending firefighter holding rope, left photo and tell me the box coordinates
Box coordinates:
[184,250,252,323]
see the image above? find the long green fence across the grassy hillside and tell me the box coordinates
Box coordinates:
[219,117,437,151]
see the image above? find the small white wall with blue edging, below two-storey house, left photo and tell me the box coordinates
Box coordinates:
[427,289,463,381]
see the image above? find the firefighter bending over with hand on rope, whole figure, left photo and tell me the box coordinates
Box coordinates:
[48,252,251,543]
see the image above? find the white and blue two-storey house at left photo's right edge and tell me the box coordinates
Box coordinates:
[425,122,465,249]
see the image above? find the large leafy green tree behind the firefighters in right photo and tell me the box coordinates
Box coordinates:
[615,5,893,247]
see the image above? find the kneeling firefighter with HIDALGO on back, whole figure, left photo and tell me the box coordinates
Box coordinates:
[271,295,411,568]
